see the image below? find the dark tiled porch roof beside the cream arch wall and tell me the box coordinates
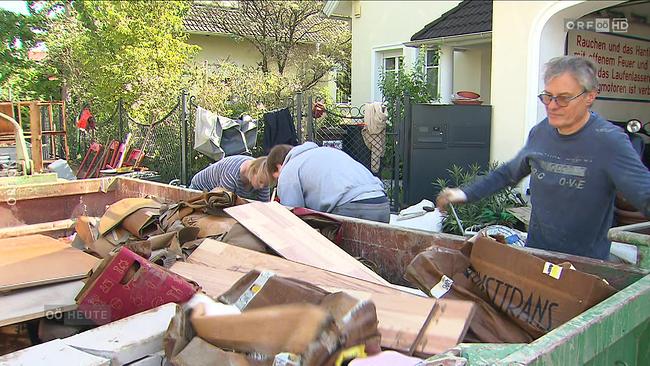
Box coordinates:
[411,0,492,41]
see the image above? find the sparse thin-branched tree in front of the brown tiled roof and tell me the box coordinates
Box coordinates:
[221,0,352,89]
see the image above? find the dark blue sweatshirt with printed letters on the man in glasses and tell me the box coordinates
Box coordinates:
[461,112,650,259]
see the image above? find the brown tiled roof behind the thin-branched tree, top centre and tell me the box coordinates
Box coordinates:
[183,3,348,43]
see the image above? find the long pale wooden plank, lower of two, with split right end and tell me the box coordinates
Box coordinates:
[172,239,474,355]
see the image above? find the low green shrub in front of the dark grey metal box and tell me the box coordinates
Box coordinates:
[433,163,524,235]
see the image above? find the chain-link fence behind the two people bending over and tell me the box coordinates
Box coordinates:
[72,93,402,211]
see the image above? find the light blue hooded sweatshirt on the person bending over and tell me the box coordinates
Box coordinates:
[278,142,385,212]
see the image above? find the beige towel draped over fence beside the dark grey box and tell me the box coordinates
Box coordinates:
[361,102,388,174]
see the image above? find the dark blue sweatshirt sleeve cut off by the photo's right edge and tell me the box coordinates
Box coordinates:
[606,134,650,217]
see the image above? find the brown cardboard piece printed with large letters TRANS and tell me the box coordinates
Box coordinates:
[469,237,616,337]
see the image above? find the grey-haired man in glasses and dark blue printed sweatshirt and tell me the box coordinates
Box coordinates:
[436,56,650,259]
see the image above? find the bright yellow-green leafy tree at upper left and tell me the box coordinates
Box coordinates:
[44,0,197,121]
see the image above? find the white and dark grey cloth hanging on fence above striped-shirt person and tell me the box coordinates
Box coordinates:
[194,107,257,160]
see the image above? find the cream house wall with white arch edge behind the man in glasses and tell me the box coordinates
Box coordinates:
[490,1,650,167]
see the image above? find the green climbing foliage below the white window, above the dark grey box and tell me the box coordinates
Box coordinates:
[379,47,437,120]
